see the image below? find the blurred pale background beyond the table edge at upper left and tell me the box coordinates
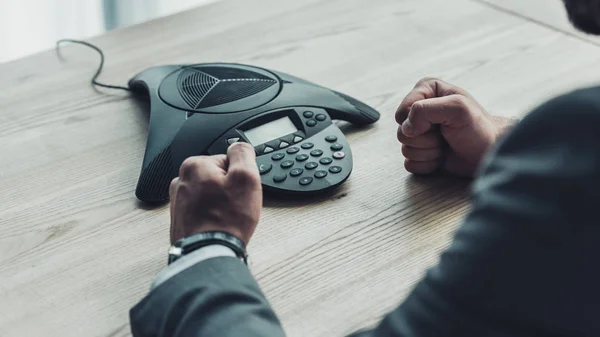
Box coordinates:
[0,0,220,63]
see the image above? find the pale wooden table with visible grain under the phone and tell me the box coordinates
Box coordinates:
[0,0,600,337]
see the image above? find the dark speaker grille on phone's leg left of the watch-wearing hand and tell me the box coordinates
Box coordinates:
[135,146,174,202]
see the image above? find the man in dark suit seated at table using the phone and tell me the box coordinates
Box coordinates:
[130,0,600,337]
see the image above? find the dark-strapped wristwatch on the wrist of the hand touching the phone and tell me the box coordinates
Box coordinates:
[169,231,248,265]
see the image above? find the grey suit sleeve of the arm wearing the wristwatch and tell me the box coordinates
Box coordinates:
[130,257,285,337]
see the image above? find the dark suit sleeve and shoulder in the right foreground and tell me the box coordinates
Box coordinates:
[346,89,600,337]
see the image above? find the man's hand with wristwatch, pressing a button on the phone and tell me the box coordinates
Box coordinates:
[170,143,262,244]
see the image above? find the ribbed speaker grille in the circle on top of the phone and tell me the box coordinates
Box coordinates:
[177,67,277,109]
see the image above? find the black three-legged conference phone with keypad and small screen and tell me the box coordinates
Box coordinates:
[129,63,380,202]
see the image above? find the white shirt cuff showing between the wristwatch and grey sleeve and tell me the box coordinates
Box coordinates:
[150,244,237,290]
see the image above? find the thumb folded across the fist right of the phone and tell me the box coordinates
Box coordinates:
[402,94,472,137]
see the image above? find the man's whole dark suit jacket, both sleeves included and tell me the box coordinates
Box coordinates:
[130,88,600,337]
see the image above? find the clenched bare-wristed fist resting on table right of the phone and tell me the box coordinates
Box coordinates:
[396,78,511,176]
